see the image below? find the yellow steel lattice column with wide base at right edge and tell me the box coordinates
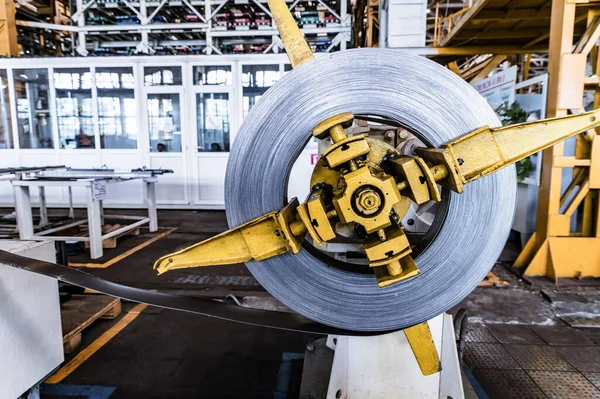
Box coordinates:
[515,0,600,284]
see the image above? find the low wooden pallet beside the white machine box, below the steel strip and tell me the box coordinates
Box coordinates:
[60,295,121,353]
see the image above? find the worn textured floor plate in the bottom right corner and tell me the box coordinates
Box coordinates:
[523,371,600,399]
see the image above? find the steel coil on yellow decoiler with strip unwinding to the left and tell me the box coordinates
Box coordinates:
[0,0,600,397]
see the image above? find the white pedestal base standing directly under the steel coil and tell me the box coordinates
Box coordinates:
[327,313,464,399]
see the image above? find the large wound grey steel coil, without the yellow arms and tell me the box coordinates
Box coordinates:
[225,49,516,331]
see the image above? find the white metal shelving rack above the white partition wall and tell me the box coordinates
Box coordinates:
[17,0,352,56]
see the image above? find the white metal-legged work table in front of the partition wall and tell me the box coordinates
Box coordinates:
[11,168,173,259]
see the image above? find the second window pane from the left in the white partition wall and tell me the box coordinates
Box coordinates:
[13,69,54,148]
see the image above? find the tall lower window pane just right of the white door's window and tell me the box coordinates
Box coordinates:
[196,93,229,152]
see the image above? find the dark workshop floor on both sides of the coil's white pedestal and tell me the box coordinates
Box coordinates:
[22,211,600,398]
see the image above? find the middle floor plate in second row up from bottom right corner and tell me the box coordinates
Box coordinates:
[505,344,575,371]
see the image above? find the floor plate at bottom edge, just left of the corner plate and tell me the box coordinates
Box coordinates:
[473,369,547,399]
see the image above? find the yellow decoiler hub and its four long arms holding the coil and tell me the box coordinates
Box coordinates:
[149,0,600,384]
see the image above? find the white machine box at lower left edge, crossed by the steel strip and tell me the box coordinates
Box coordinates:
[0,240,64,398]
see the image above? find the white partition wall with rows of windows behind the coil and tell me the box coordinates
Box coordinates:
[0,54,316,209]
